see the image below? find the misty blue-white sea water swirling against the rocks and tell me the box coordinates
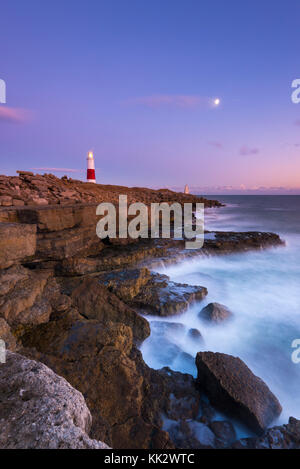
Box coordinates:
[141,196,300,430]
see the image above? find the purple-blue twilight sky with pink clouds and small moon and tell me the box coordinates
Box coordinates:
[0,0,300,193]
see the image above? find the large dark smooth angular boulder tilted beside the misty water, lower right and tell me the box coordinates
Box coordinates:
[196,352,282,434]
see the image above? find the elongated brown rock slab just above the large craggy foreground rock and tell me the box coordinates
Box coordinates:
[72,278,150,341]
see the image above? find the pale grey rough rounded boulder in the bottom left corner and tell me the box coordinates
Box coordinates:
[0,352,108,449]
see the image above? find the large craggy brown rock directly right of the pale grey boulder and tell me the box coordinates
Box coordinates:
[22,314,170,448]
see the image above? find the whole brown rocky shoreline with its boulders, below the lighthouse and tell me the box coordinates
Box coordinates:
[0,172,300,449]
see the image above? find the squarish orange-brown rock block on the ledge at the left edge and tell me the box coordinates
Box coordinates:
[0,223,36,269]
